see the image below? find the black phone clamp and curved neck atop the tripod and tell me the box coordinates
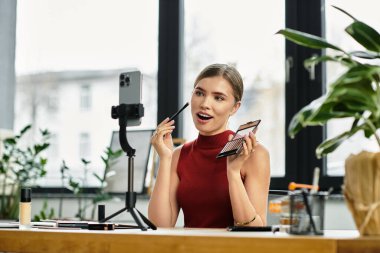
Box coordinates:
[111,104,144,157]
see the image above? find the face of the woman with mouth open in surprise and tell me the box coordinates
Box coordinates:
[191,76,240,135]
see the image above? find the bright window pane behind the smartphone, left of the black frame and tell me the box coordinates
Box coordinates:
[15,0,158,186]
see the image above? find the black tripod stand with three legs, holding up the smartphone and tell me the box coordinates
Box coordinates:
[100,104,157,231]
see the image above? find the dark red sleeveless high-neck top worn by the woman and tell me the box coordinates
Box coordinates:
[177,130,234,228]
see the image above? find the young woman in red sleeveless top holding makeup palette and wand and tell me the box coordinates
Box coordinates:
[148,64,270,228]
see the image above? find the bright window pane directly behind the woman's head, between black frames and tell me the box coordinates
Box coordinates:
[184,0,285,176]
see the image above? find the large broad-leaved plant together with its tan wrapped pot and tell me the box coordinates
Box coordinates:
[278,6,380,235]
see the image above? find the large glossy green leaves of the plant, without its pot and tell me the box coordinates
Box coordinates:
[278,6,380,157]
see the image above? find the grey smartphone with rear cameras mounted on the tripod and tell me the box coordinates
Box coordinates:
[119,69,142,126]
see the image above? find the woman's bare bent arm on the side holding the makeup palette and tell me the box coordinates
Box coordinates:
[227,139,270,226]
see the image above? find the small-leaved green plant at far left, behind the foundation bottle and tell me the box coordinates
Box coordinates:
[0,125,50,219]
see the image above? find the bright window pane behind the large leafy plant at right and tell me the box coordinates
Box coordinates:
[325,0,380,176]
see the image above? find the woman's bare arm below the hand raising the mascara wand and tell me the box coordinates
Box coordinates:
[148,147,181,227]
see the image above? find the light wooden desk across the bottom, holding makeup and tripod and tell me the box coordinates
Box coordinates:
[0,229,380,253]
